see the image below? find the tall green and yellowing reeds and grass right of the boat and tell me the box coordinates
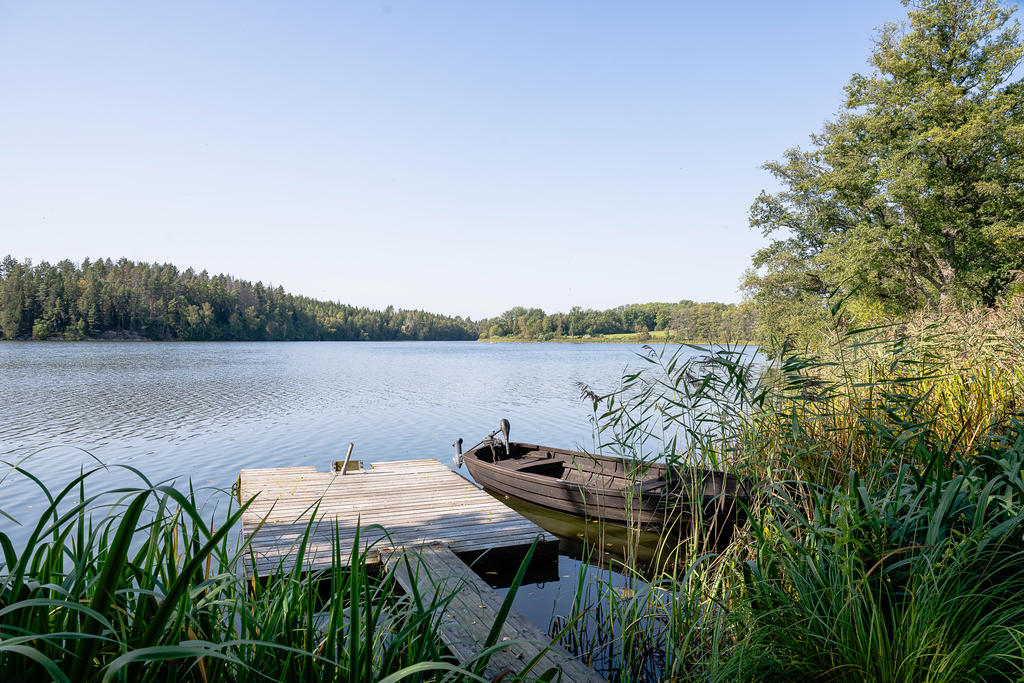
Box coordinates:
[552,300,1024,681]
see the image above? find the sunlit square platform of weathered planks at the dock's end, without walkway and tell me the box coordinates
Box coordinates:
[239,460,556,575]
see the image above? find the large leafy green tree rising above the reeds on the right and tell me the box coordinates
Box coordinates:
[744,0,1024,339]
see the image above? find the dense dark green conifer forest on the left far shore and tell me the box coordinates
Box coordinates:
[0,256,479,341]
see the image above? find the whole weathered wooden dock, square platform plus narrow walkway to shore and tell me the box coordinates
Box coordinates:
[238,460,603,681]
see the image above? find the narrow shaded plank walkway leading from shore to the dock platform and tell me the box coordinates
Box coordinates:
[386,544,604,681]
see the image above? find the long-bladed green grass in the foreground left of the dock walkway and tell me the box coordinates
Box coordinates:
[0,465,499,682]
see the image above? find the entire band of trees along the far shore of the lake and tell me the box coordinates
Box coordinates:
[0,256,756,342]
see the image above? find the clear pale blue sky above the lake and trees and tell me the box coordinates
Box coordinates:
[0,0,904,317]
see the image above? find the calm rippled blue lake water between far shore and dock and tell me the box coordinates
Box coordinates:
[0,342,720,663]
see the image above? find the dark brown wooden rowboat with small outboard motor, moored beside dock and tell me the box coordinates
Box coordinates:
[454,420,750,530]
